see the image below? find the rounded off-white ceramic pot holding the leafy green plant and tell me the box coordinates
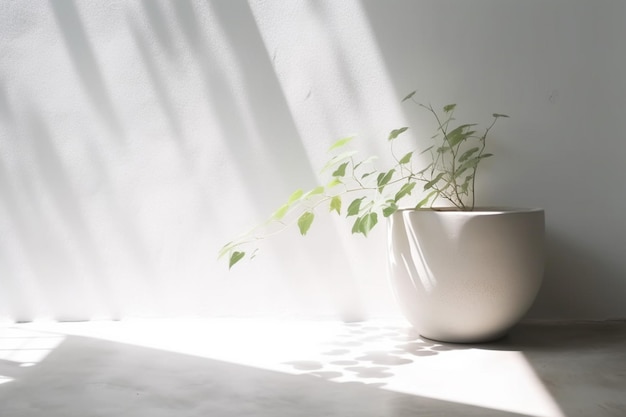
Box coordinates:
[388,209,545,343]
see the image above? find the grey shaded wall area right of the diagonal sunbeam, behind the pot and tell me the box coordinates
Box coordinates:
[356,0,626,319]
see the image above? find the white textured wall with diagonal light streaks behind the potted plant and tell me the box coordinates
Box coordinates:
[0,0,626,320]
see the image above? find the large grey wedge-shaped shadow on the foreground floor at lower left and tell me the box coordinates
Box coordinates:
[0,328,532,417]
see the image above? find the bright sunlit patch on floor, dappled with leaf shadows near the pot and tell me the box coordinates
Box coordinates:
[0,319,563,417]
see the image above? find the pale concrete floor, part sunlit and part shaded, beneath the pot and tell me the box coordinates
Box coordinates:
[0,319,626,417]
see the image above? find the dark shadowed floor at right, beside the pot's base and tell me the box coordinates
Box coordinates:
[486,320,626,417]
